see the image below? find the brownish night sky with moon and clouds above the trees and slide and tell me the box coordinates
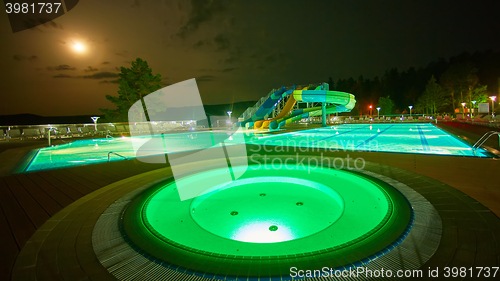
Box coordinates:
[0,0,500,116]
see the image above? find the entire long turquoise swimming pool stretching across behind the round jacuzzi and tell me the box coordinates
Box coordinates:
[25,123,489,172]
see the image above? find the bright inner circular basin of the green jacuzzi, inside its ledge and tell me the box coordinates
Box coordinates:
[189,175,346,243]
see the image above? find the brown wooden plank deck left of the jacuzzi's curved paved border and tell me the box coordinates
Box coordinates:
[0,156,165,280]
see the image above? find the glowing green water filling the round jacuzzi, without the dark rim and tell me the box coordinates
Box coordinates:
[143,165,392,255]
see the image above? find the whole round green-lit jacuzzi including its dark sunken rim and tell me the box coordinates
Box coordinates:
[121,165,412,277]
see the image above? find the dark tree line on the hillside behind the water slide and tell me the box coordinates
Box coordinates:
[328,51,500,114]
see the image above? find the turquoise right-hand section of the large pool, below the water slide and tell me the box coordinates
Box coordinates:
[252,123,489,157]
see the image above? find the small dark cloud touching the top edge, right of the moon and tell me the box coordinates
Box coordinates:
[177,0,224,38]
